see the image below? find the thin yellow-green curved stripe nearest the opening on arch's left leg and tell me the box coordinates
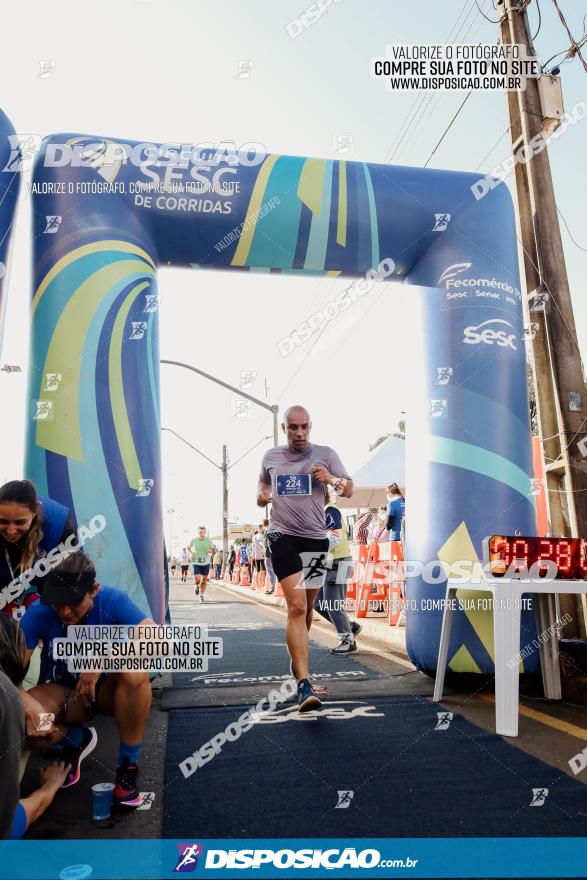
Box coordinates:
[108,281,150,489]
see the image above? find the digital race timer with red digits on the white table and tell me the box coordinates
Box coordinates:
[483,535,587,581]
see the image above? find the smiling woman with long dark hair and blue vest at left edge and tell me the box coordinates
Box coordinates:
[0,480,74,620]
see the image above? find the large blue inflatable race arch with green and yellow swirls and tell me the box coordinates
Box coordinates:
[1,111,537,672]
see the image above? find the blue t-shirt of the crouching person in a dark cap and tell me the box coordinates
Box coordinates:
[20,586,148,681]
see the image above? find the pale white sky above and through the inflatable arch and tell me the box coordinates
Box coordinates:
[0,0,587,546]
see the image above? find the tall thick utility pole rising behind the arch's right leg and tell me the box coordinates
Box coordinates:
[497,0,587,638]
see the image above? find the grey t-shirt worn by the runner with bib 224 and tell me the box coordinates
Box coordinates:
[259,443,350,538]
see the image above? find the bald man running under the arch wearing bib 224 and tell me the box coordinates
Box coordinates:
[257,406,353,712]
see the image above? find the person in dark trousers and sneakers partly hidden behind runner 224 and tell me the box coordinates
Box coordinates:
[314,486,362,654]
